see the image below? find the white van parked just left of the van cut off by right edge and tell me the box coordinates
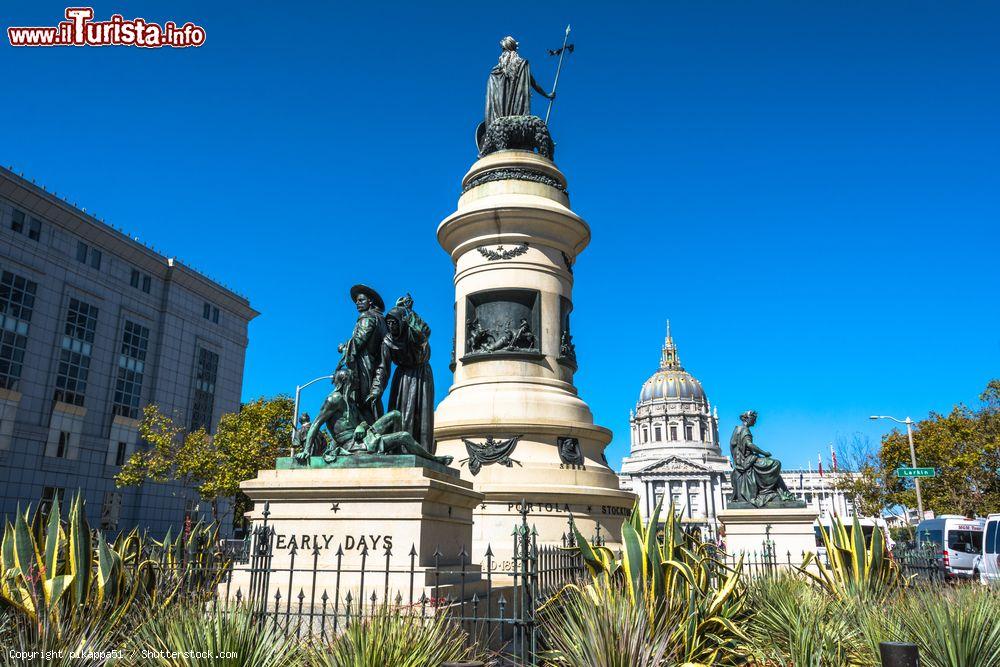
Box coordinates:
[917,514,986,579]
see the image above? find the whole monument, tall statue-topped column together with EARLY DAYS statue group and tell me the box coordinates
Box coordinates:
[235,31,634,595]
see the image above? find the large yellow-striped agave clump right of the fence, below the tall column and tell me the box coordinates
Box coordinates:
[550,502,746,665]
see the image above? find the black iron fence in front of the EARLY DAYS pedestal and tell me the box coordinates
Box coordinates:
[185,504,592,665]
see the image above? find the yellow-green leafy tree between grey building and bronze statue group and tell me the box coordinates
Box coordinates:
[115,396,293,520]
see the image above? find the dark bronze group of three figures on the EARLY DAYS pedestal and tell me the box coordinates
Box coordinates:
[293,285,452,465]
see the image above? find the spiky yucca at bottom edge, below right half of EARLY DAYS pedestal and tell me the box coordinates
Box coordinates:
[310,604,474,667]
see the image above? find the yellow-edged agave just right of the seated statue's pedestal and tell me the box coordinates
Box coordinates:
[801,517,905,602]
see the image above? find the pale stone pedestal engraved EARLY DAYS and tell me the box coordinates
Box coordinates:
[227,455,486,607]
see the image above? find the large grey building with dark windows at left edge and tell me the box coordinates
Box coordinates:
[0,168,258,536]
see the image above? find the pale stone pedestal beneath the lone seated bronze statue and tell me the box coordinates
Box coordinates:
[718,506,819,567]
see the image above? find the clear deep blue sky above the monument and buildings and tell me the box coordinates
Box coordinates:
[0,0,1000,467]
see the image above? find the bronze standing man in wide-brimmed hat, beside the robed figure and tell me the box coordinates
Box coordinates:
[337,285,386,424]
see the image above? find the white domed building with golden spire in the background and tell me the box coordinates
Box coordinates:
[620,322,853,536]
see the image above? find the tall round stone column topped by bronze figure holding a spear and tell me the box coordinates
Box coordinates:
[434,37,634,559]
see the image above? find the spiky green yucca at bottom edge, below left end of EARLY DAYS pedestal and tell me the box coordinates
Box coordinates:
[131,604,304,667]
